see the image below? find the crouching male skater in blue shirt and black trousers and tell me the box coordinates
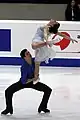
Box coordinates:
[1,49,52,115]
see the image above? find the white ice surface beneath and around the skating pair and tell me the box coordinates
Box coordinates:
[0,66,80,120]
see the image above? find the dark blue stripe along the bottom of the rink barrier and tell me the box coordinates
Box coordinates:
[0,57,80,67]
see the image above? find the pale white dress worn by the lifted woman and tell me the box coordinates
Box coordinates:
[32,27,60,63]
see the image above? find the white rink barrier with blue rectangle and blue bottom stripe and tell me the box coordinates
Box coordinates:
[0,20,80,67]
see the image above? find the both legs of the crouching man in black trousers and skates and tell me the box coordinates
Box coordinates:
[1,81,52,115]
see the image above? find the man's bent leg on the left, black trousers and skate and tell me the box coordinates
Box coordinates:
[1,81,24,115]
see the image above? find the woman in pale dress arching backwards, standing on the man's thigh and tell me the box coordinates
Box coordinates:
[32,19,77,84]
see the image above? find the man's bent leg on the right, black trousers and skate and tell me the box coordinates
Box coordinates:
[32,82,52,113]
